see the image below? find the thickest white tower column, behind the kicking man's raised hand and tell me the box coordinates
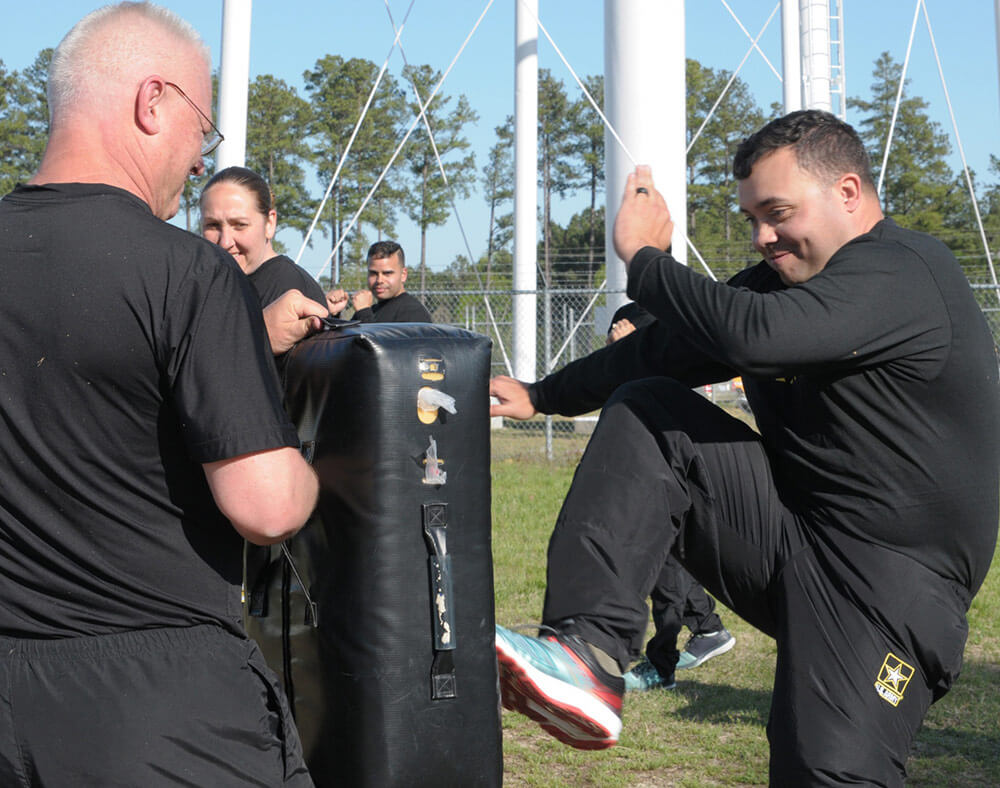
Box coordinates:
[598,0,687,320]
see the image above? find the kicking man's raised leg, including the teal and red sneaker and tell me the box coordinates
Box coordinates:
[497,378,798,748]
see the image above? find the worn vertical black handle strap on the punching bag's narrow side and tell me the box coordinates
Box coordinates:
[422,503,456,700]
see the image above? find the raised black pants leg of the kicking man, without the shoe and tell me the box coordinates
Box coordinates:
[543,378,805,669]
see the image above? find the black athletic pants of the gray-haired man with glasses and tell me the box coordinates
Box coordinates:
[0,625,313,788]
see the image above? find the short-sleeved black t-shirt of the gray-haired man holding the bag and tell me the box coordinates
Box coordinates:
[0,184,298,638]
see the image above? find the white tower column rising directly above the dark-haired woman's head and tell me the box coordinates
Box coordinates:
[215,0,252,170]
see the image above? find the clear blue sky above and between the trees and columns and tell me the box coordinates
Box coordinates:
[0,0,1000,280]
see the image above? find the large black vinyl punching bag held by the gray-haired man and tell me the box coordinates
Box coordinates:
[247,323,503,788]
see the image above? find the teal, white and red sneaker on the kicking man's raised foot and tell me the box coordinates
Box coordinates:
[496,626,625,750]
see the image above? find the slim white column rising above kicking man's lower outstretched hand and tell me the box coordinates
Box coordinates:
[511,0,538,381]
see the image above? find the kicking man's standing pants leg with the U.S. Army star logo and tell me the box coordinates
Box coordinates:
[768,535,968,786]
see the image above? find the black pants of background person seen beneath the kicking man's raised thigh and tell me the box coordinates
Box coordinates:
[646,554,722,677]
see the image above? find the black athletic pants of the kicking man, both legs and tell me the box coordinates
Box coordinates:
[543,378,969,786]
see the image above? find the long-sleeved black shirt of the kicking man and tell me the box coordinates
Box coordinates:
[530,219,1000,592]
